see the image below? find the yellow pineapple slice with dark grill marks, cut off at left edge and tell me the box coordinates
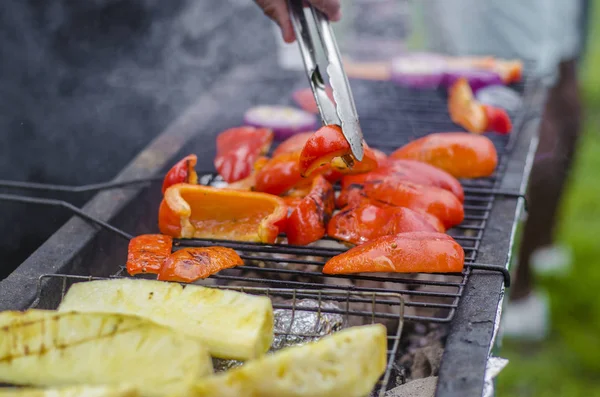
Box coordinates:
[0,310,212,396]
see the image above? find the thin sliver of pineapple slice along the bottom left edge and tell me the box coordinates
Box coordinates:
[0,386,141,397]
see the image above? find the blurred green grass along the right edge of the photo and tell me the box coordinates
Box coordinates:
[497,0,600,397]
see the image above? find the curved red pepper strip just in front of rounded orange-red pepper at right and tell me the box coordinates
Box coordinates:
[341,159,465,203]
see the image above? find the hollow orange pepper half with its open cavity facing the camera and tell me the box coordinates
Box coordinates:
[158,184,287,243]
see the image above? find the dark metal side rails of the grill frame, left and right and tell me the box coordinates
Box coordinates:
[0,60,542,396]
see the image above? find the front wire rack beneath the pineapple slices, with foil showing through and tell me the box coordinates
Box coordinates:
[31,274,404,397]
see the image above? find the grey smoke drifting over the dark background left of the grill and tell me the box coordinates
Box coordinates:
[0,0,274,276]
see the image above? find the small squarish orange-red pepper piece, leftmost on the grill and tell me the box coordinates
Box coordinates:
[127,234,173,276]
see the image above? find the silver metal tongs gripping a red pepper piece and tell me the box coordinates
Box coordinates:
[288,0,364,161]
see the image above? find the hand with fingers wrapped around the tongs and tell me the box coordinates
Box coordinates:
[254,0,342,43]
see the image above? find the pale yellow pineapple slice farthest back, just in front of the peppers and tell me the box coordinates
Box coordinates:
[58,279,273,360]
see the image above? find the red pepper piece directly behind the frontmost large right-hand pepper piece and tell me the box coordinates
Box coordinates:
[327,204,438,244]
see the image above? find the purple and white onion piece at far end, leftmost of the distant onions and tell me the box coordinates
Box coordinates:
[392,53,446,88]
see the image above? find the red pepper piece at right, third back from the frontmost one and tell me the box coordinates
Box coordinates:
[364,177,465,229]
